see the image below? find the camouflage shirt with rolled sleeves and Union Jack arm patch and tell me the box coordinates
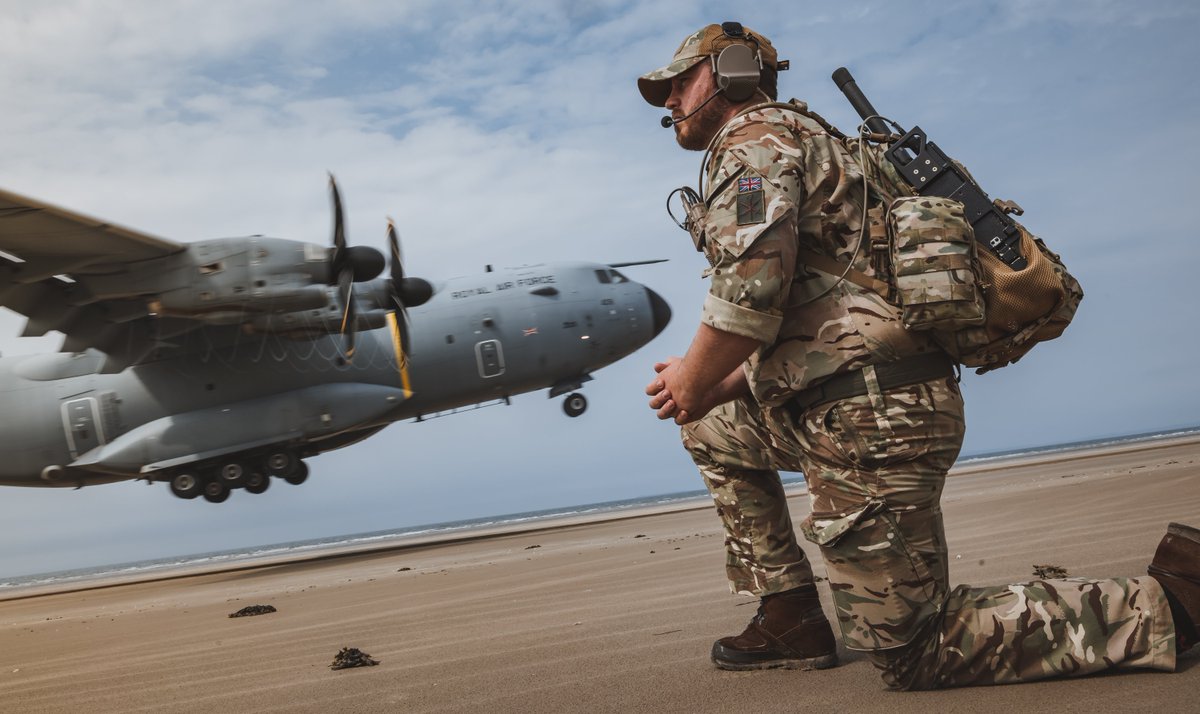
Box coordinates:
[702,102,937,406]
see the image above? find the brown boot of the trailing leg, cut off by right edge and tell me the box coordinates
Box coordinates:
[1147,523,1200,652]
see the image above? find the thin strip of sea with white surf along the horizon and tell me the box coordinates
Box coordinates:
[0,426,1200,599]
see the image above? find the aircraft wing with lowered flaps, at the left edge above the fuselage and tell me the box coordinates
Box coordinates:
[0,191,185,368]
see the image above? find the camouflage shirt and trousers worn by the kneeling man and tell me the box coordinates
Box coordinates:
[683,104,1175,689]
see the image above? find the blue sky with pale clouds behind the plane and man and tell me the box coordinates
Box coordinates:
[0,0,1200,581]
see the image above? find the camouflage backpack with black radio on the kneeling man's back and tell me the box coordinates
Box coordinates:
[793,68,1084,374]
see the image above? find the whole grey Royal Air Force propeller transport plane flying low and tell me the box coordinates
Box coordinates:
[0,180,671,503]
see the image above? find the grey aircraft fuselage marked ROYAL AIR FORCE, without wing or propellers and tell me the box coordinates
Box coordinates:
[0,263,670,494]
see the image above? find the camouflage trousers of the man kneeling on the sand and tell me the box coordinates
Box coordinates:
[683,367,1175,689]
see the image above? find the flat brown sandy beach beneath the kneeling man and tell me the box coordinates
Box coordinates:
[0,438,1200,713]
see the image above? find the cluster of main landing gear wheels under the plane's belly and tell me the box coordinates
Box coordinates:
[167,449,308,503]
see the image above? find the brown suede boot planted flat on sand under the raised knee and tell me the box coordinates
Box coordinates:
[713,584,838,670]
